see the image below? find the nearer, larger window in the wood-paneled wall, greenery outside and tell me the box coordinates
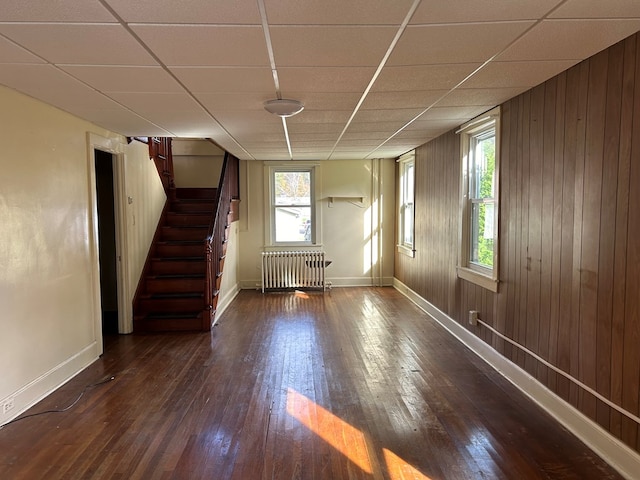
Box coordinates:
[458,108,499,291]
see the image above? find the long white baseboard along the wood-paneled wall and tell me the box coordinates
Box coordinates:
[393,279,640,479]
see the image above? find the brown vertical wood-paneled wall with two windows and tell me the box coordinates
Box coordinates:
[396,34,640,451]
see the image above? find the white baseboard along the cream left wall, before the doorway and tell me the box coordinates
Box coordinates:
[0,342,100,425]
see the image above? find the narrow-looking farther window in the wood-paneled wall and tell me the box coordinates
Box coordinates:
[398,151,415,257]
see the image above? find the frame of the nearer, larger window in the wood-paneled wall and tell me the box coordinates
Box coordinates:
[456,107,500,292]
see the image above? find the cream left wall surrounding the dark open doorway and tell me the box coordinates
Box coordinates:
[0,87,164,424]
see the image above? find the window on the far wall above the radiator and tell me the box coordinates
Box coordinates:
[267,167,316,245]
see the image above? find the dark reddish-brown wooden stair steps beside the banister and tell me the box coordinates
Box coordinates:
[133,188,218,332]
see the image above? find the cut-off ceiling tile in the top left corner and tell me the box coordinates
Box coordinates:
[0,0,115,23]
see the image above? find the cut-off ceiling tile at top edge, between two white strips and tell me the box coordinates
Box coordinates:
[264,0,413,25]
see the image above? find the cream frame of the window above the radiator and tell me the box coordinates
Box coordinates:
[264,163,320,247]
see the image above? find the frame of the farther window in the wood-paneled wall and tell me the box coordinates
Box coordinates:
[396,150,416,257]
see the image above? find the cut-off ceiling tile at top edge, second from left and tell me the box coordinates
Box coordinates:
[106,0,260,25]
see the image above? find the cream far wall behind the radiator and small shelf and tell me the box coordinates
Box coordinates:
[238,159,395,288]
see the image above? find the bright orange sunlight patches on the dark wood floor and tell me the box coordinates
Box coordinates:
[287,388,430,480]
